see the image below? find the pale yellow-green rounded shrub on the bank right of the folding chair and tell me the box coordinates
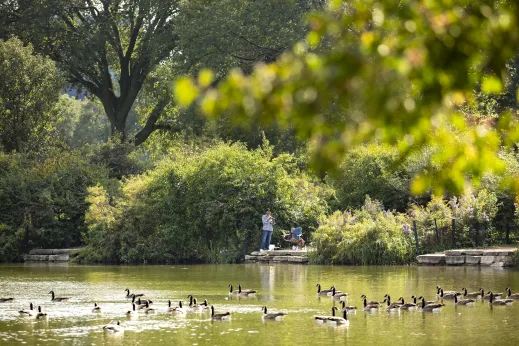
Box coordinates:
[313,197,415,265]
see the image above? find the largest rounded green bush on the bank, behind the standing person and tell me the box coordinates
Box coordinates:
[83,144,330,263]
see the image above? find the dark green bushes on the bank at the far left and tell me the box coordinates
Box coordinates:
[0,153,107,261]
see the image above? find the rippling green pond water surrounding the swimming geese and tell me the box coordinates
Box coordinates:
[0,264,519,345]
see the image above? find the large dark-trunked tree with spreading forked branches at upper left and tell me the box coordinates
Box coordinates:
[10,0,180,144]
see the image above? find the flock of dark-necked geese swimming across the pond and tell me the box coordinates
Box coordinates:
[0,284,519,333]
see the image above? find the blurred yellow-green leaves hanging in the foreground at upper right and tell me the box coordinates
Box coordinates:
[174,0,519,193]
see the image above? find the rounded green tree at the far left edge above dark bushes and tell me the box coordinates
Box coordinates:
[0,38,63,152]
